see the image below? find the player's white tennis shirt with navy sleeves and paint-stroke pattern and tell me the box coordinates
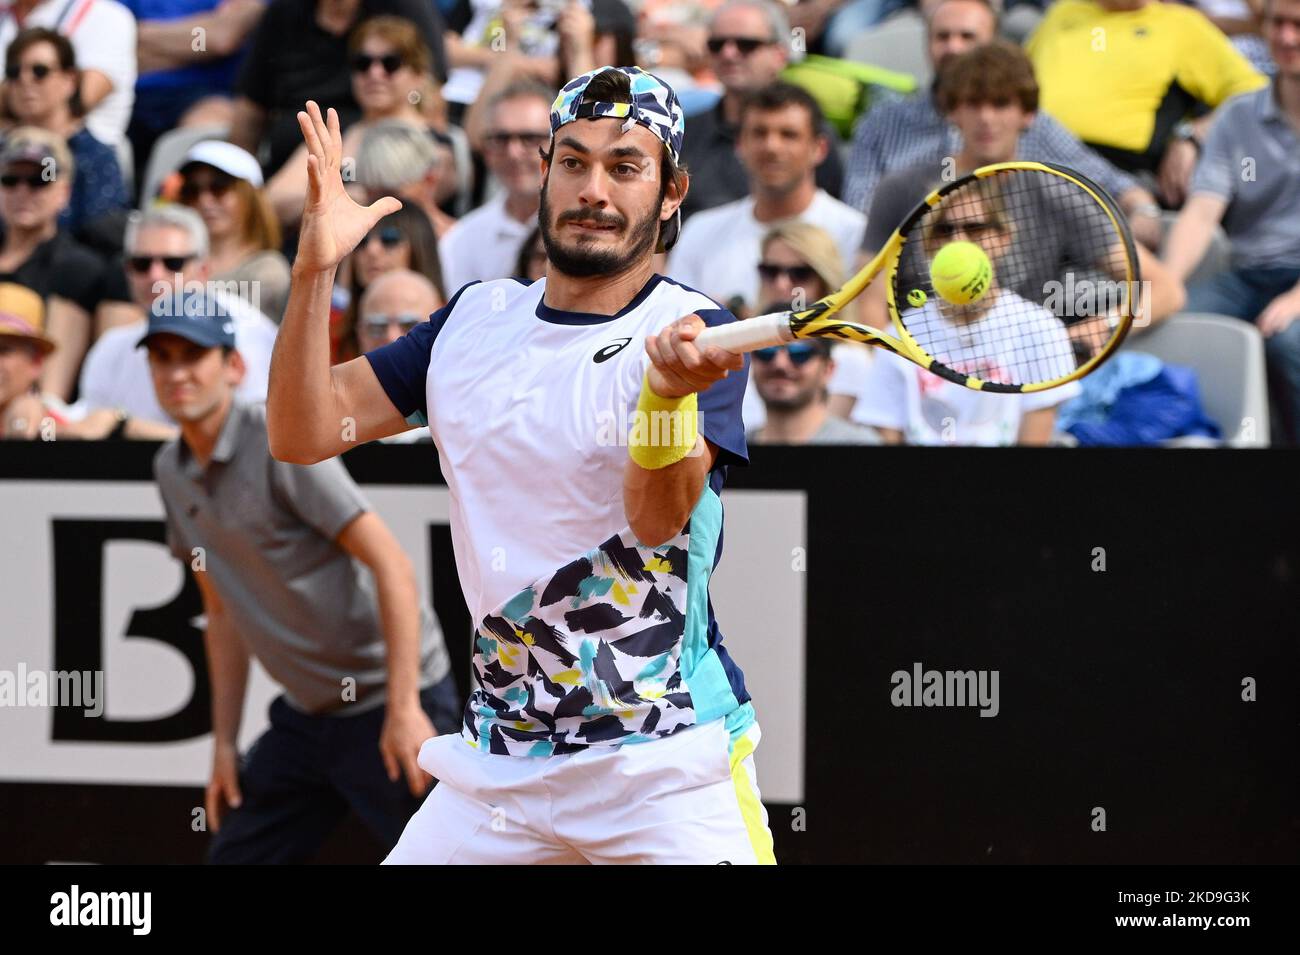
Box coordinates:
[367,275,753,756]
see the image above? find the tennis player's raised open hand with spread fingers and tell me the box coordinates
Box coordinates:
[294,100,402,272]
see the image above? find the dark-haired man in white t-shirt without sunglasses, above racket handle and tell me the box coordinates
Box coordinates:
[668,82,866,309]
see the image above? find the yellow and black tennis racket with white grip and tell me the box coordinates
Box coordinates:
[696,162,1140,394]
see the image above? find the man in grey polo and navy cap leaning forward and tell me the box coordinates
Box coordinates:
[140,292,460,863]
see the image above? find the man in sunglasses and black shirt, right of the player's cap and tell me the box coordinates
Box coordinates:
[681,0,844,218]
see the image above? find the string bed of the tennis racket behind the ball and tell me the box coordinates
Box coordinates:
[893,169,1131,388]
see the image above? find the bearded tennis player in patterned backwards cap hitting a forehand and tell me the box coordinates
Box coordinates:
[268,68,775,864]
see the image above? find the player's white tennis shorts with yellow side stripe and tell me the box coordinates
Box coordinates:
[384,720,776,865]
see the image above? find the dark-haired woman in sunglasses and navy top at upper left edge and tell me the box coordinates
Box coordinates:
[4,26,130,242]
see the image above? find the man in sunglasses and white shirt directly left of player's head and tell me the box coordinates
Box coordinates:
[438,81,554,295]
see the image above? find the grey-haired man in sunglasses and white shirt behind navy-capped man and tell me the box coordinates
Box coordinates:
[75,205,276,434]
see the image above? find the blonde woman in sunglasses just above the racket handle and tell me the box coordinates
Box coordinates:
[742,222,871,430]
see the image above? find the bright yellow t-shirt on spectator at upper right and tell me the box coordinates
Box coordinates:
[1026,0,1268,166]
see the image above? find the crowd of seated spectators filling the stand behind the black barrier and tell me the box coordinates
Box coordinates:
[0,0,1300,444]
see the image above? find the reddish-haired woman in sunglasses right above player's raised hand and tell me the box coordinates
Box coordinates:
[267,17,442,229]
